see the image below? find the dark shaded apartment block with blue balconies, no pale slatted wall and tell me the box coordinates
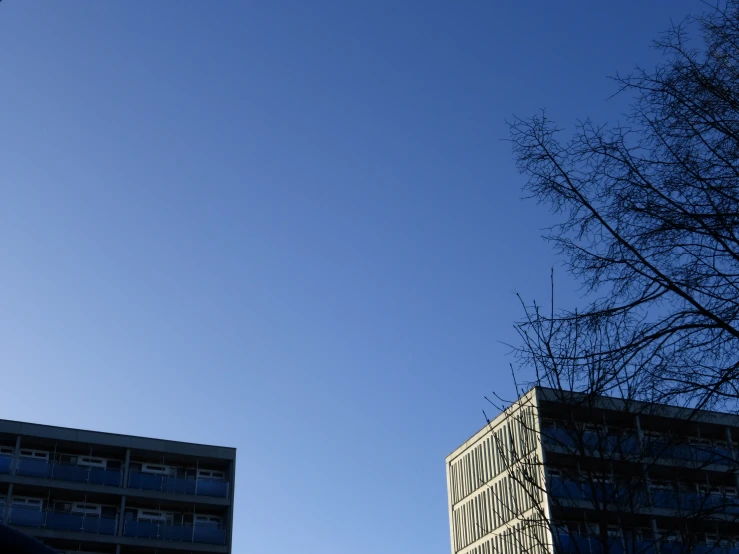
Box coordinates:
[0,420,236,554]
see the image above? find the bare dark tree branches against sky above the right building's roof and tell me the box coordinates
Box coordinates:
[510,0,739,411]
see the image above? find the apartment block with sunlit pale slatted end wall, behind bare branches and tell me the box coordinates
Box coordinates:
[446,388,739,554]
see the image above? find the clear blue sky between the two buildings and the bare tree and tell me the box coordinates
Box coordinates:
[0,0,702,554]
